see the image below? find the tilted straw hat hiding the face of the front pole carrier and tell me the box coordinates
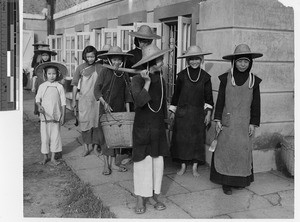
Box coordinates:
[132,44,172,68]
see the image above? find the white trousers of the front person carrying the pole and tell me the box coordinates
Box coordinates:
[133,156,164,197]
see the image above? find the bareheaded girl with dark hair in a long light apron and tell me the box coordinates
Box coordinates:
[71,46,101,157]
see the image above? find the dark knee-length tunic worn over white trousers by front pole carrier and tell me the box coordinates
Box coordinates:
[132,72,169,162]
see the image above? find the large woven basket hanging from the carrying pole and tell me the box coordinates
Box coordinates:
[100,112,135,149]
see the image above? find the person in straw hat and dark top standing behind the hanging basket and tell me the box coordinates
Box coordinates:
[94,46,132,175]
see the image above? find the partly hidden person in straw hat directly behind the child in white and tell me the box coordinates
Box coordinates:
[32,46,57,115]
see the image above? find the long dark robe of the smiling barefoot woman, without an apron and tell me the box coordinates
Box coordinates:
[171,67,213,163]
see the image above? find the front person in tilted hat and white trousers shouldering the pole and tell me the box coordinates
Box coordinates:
[131,45,169,214]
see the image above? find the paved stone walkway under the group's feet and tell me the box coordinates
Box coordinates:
[24,90,294,219]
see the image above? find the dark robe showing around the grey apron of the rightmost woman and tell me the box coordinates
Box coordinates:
[210,64,261,187]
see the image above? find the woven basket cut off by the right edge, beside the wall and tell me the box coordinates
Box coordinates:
[281,137,295,176]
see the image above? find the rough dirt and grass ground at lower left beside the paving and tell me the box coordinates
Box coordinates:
[23,91,115,218]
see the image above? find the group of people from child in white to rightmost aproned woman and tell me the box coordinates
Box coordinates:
[31,25,262,214]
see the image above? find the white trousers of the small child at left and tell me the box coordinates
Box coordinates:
[41,121,62,154]
